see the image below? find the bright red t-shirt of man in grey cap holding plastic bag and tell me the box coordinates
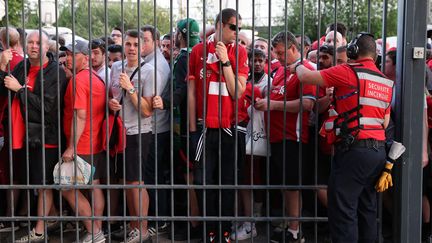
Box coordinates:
[63,69,106,155]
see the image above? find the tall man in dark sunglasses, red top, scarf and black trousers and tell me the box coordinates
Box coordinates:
[188,9,249,242]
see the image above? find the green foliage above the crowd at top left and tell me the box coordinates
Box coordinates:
[56,0,170,39]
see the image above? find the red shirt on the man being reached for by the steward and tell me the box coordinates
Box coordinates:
[266,60,316,143]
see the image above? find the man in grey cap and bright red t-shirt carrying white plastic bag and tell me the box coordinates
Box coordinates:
[60,40,107,243]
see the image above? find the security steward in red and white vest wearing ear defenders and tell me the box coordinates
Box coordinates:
[290,33,393,243]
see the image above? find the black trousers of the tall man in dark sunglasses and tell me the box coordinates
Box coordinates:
[194,128,236,232]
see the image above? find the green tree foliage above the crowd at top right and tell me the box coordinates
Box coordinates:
[253,0,397,40]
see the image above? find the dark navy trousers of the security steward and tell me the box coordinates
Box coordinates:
[328,147,386,243]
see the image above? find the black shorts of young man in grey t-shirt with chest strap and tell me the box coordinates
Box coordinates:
[119,132,151,181]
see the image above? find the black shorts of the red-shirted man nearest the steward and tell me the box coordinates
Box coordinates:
[270,140,306,186]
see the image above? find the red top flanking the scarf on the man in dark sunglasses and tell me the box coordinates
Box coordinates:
[188,41,249,123]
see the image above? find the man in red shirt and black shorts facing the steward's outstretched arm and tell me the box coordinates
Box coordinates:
[255,32,316,242]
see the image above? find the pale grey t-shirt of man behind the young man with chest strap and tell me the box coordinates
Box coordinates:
[144,49,171,134]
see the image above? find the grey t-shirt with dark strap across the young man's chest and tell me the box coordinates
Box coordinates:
[110,60,155,135]
